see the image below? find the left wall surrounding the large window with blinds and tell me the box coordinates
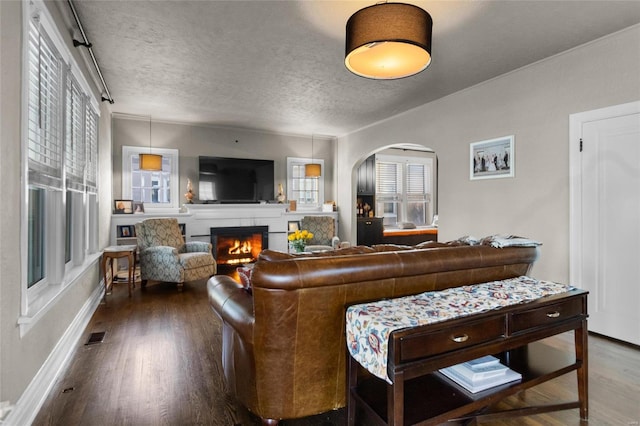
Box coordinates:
[0,1,111,412]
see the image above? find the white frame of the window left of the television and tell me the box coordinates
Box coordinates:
[122,146,180,212]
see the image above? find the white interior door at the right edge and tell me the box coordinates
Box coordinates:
[577,108,640,344]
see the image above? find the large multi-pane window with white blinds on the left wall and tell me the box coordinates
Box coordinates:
[19,0,98,331]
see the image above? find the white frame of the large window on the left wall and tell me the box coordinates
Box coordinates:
[18,0,100,336]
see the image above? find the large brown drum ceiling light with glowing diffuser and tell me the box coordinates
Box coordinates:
[344,3,433,80]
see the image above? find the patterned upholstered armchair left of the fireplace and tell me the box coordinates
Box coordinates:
[136,218,216,288]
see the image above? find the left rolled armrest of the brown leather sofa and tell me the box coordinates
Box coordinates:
[207,275,255,345]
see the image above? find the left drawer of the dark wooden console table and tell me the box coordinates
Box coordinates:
[396,315,506,363]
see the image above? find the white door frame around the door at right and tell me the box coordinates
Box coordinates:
[569,101,640,287]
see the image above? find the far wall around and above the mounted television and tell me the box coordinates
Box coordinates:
[113,115,335,204]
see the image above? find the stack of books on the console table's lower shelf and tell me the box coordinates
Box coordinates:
[440,355,522,393]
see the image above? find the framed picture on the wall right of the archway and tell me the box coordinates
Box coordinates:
[469,135,515,180]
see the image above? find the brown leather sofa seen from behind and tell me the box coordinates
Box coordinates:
[208,243,538,424]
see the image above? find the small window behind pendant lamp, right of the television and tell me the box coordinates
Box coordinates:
[287,157,325,210]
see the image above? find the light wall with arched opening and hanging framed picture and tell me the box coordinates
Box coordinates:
[336,26,640,282]
